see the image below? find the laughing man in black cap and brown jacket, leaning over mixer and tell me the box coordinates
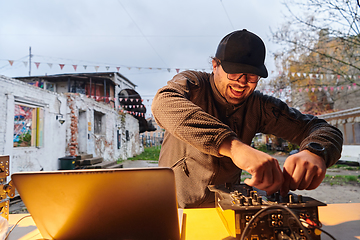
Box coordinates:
[152,29,343,208]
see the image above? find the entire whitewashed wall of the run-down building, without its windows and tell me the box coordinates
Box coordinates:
[0,76,143,180]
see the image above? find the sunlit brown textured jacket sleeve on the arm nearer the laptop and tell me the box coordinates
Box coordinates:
[151,71,236,157]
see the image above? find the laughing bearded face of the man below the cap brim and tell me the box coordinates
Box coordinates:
[212,60,257,104]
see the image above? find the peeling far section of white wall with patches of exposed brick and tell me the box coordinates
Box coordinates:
[66,93,143,161]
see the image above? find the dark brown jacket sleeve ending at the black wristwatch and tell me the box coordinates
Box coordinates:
[258,93,343,167]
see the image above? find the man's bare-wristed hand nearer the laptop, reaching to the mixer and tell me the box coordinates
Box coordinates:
[219,138,284,195]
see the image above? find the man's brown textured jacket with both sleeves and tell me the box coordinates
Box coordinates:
[152,71,343,208]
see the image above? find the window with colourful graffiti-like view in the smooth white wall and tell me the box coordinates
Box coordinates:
[13,103,44,147]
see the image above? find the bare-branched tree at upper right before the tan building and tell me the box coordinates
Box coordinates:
[272,0,360,114]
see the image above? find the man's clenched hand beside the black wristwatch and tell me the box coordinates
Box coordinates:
[280,150,326,196]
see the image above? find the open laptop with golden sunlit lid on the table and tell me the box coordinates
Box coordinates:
[11,168,181,240]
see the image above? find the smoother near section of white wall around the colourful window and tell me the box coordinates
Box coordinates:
[0,76,66,174]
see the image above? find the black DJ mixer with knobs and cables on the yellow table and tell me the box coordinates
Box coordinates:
[209,184,326,240]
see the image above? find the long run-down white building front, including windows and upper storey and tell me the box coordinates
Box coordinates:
[0,74,143,174]
